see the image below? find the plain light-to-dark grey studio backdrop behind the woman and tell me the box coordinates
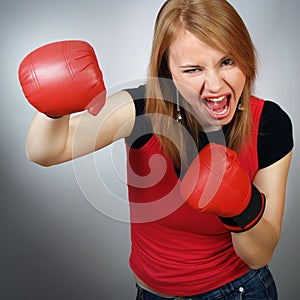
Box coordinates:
[0,0,300,300]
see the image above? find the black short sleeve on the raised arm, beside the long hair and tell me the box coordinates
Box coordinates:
[125,85,153,149]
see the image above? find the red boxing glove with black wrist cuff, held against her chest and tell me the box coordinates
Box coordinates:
[180,143,265,232]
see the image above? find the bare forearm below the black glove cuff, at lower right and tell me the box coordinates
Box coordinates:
[232,218,280,269]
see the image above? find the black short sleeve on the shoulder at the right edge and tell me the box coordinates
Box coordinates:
[258,101,294,169]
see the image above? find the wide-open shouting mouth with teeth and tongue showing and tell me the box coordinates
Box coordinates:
[203,95,231,119]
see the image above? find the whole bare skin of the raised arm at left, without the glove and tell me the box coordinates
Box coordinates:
[26,91,135,166]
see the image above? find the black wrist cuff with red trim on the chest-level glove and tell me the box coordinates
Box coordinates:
[219,185,266,232]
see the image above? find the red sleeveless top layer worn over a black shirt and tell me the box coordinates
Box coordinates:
[127,97,264,296]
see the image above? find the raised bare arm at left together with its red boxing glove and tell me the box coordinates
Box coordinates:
[19,41,135,166]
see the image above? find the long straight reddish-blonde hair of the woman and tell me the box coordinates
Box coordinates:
[146,0,256,167]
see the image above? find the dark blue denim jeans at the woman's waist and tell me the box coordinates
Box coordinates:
[136,266,278,300]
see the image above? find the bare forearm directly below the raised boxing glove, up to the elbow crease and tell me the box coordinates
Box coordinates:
[26,112,69,166]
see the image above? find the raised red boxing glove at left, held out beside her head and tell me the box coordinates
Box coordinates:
[19,40,106,117]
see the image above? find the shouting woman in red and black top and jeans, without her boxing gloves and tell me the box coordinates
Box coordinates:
[22,0,293,300]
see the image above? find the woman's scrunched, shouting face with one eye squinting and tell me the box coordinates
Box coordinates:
[169,31,246,131]
